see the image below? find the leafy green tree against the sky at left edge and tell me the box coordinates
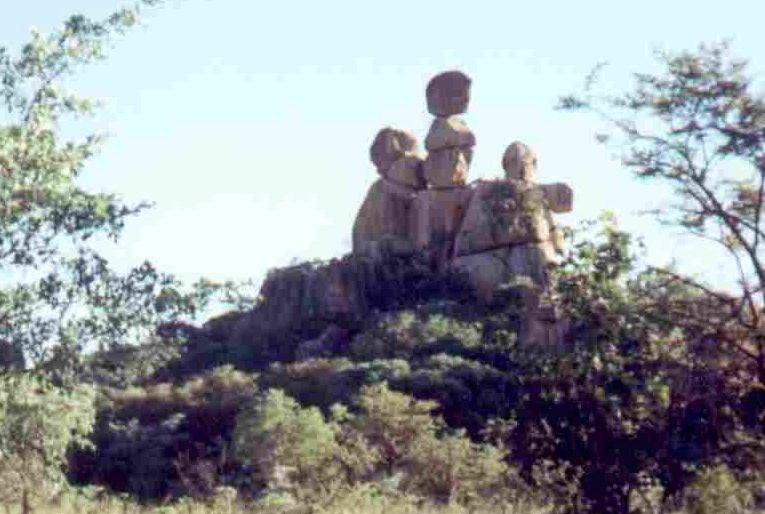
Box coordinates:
[0,0,254,374]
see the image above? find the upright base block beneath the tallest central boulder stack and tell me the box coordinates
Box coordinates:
[409,187,473,262]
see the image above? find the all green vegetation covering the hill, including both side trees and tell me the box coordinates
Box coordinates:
[0,2,765,513]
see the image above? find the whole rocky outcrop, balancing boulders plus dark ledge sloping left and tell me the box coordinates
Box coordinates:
[245,71,573,346]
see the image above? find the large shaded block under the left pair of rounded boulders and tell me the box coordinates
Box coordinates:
[353,179,415,256]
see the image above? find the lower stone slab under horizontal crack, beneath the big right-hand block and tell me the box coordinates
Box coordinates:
[452,243,550,299]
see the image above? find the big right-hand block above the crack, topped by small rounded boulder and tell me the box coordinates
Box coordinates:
[454,180,552,255]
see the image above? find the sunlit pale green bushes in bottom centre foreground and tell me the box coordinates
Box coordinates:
[234,384,528,505]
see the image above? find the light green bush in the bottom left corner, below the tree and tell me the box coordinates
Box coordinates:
[0,373,95,504]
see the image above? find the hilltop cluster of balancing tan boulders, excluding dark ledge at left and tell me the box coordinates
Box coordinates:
[353,71,573,342]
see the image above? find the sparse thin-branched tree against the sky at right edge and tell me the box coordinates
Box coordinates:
[560,43,765,384]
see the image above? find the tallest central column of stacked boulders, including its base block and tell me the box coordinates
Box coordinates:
[410,71,475,265]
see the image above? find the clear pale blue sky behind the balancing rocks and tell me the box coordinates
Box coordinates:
[0,0,765,288]
